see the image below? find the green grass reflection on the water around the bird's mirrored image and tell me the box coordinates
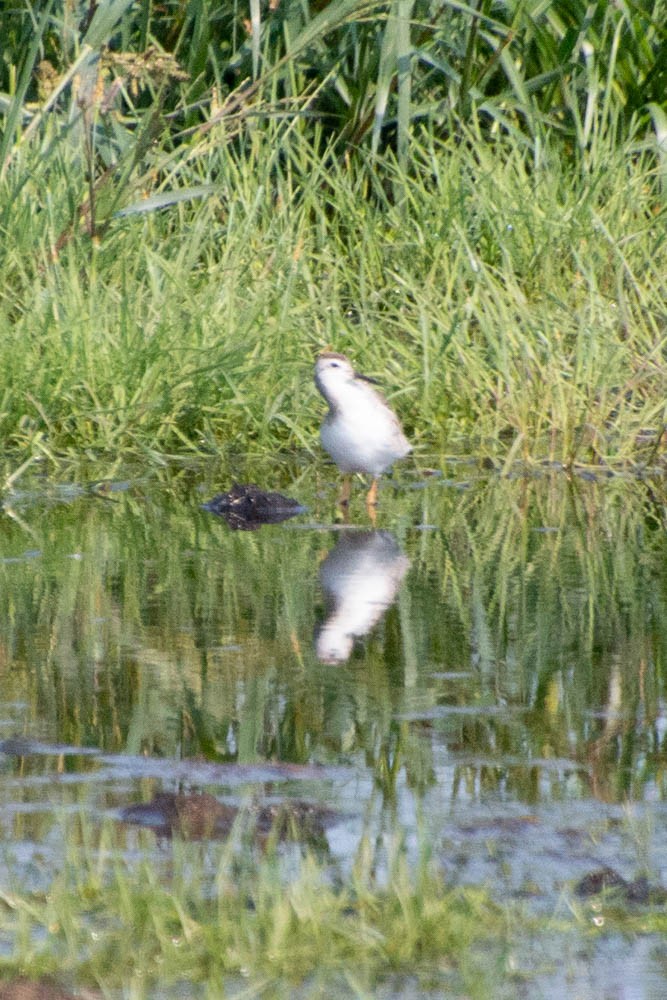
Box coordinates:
[0,466,667,801]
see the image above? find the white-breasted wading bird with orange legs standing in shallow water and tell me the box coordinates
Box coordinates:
[315,351,412,513]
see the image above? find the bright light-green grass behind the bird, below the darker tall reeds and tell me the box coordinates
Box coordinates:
[0,117,667,472]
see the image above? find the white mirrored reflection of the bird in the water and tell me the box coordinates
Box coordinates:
[315,531,410,664]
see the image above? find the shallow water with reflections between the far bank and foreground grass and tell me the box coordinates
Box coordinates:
[0,463,667,997]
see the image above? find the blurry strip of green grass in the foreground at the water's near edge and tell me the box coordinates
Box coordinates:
[0,813,665,1000]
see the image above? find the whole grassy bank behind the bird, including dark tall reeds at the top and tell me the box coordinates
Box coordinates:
[0,0,667,467]
